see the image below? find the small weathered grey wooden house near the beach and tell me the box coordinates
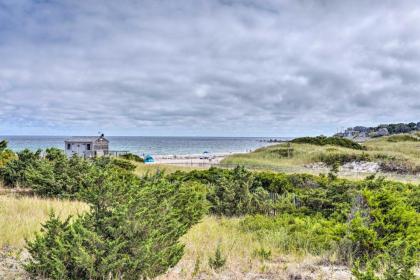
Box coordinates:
[64,134,109,158]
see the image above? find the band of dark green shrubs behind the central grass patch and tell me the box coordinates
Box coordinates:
[168,168,357,220]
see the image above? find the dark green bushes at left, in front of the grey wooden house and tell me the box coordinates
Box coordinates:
[0,148,136,199]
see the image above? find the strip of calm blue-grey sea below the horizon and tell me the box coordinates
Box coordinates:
[0,136,287,155]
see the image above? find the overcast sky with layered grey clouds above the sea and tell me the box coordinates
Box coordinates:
[0,0,420,136]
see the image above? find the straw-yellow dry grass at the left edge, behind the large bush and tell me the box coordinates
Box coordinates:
[0,195,88,248]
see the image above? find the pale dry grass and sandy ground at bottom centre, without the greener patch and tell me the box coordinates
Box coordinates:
[159,217,350,280]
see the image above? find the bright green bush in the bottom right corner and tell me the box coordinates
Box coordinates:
[347,187,420,279]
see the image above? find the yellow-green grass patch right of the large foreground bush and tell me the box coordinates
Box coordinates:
[158,216,335,280]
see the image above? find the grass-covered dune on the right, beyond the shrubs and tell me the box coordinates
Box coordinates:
[222,134,420,178]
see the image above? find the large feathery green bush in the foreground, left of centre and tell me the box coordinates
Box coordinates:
[26,171,206,279]
